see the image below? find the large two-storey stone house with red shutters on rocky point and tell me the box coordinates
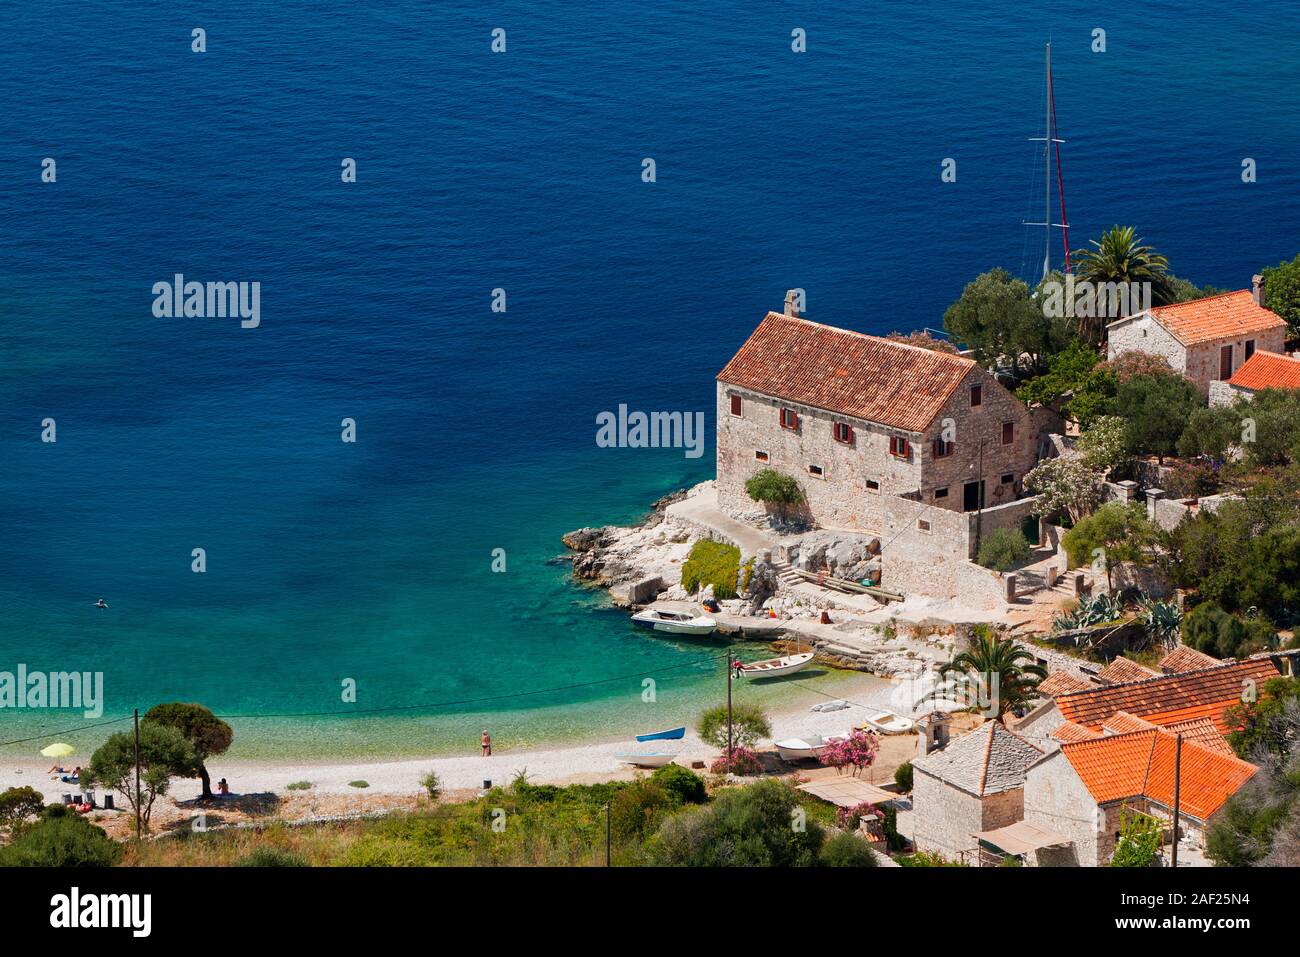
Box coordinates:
[716,304,1043,533]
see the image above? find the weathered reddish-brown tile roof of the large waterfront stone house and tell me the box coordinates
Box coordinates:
[718,312,975,432]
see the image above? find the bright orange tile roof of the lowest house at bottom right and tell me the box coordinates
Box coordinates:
[1061,728,1256,820]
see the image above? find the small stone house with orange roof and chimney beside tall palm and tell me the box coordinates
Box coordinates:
[1106,276,1287,397]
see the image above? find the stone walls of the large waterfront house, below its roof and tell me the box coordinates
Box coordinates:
[718,367,1041,533]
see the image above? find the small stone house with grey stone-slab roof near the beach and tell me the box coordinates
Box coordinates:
[911,720,1043,863]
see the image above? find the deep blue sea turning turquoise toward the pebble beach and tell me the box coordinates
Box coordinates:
[0,0,1300,755]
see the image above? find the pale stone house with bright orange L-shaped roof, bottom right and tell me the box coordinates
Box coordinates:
[1023,727,1257,867]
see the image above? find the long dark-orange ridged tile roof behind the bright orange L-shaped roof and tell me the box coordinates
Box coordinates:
[1056,658,1279,731]
